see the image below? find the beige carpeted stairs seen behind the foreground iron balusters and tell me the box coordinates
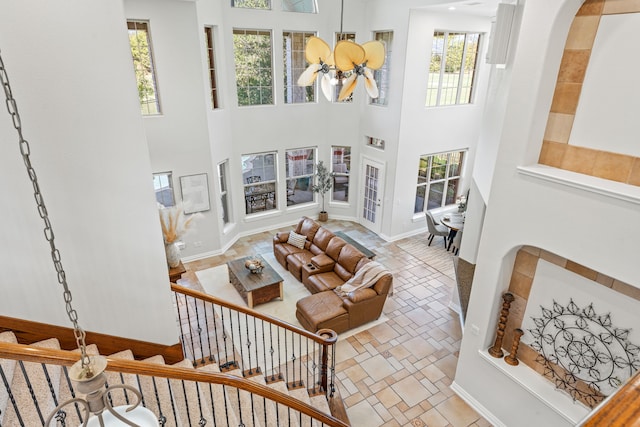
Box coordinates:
[0,332,330,427]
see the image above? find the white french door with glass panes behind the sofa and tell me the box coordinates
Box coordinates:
[359,157,384,233]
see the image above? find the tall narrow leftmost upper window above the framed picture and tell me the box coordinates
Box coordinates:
[127,20,160,115]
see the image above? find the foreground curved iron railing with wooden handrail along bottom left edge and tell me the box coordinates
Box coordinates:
[0,342,348,427]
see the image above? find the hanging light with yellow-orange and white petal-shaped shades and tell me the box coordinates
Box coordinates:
[298,0,385,101]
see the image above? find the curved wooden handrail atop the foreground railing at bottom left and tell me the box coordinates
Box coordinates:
[0,342,349,427]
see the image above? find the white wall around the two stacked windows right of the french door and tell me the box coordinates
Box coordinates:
[385,9,491,241]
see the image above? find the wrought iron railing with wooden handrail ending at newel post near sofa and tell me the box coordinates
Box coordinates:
[171,283,337,398]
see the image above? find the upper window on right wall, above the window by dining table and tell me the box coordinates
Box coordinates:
[426,31,481,107]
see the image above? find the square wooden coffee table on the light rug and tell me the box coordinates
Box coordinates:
[227,255,284,308]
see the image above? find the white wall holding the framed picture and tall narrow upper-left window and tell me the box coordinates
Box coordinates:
[124,0,221,257]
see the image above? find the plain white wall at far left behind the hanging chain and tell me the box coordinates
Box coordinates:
[0,0,178,344]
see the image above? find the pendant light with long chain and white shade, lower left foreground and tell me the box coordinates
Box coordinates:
[0,49,158,427]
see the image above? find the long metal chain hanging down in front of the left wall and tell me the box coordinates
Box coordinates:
[0,49,89,368]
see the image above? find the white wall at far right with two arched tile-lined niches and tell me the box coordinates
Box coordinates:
[455,0,640,426]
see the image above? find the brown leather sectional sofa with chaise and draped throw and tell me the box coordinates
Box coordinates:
[273,217,393,333]
